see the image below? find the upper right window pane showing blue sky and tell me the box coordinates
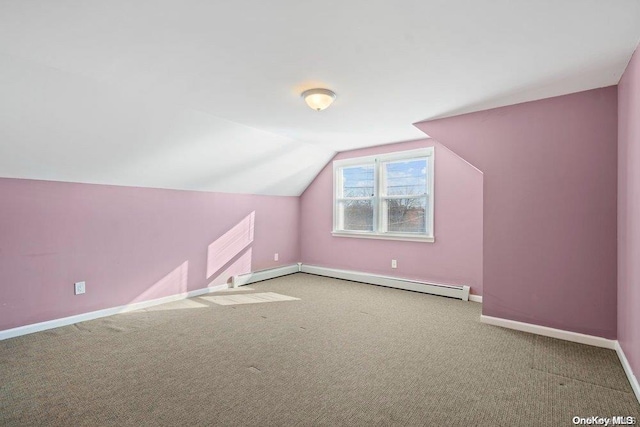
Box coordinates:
[384,159,427,196]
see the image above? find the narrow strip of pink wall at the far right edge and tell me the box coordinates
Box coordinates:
[618,49,640,377]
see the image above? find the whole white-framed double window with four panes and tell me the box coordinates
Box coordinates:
[333,147,434,242]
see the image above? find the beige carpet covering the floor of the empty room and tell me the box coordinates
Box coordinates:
[0,273,640,426]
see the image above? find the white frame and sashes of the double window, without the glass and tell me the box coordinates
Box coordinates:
[331,147,435,243]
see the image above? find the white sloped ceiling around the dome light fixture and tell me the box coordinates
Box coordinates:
[0,0,640,195]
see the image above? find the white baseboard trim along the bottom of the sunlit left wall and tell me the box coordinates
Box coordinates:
[0,284,229,341]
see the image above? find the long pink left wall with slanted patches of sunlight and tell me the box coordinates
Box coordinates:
[0,179,300,330]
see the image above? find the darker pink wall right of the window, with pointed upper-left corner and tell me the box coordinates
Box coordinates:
[416,86,617,338]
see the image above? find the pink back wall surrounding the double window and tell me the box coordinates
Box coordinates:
[300,140,482,295]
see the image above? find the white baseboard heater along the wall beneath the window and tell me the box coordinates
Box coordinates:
[300,264,470,301]
